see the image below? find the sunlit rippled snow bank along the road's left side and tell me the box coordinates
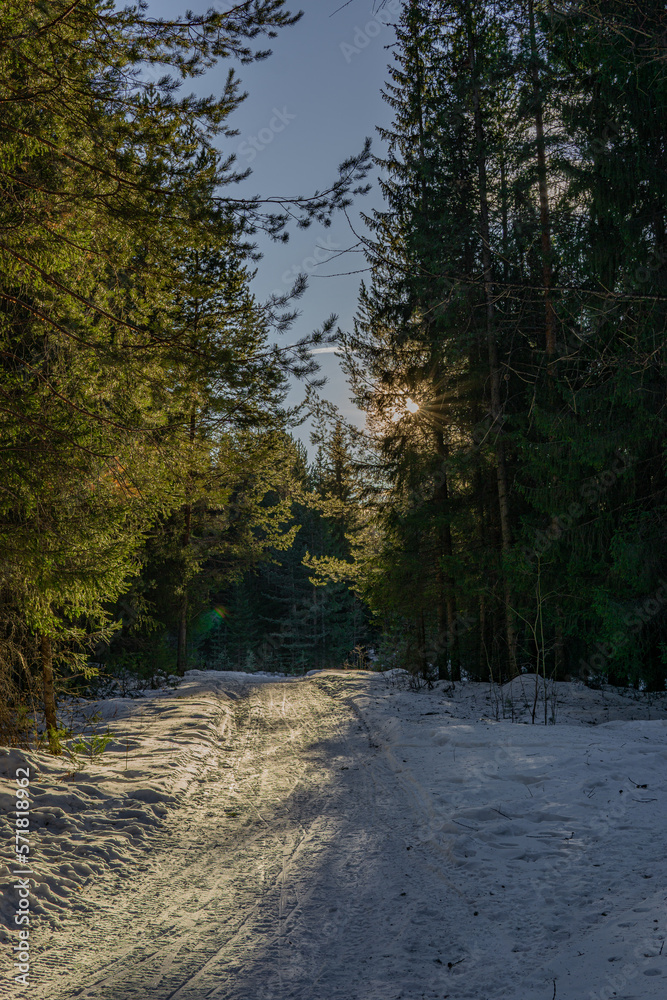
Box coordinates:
[0,670,240,939]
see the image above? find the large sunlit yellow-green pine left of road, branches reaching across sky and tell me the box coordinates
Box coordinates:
[0,0,366,729]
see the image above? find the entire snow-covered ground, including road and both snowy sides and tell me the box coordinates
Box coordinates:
[0,671,667,1000]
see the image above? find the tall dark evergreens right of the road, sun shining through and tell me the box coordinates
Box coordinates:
[336,0,667,689]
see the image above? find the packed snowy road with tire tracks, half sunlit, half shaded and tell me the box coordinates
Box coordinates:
[30,679,461,1000]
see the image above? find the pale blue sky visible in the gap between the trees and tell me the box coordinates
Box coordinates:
[151,0,401,439]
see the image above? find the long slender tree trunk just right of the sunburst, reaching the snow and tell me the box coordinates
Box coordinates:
[466,3,519,677]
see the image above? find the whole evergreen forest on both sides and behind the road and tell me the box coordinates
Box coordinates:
[0,0,667,746]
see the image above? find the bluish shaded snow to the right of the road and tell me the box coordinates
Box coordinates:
[342,674,667,1000]
